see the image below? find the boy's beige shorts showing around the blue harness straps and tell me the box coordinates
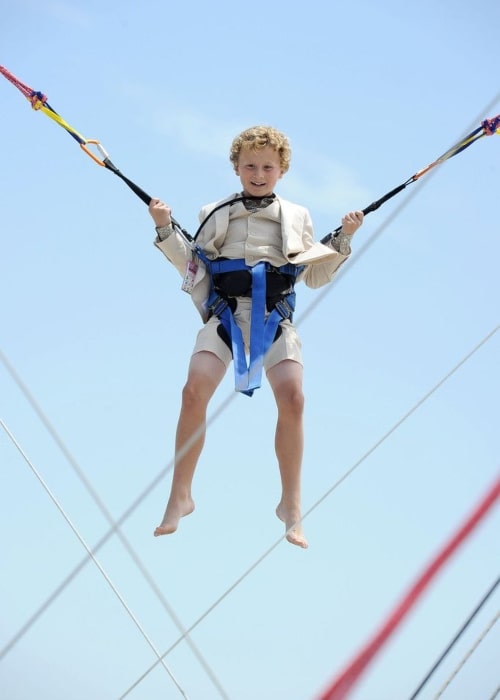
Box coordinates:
[193,297,302,371]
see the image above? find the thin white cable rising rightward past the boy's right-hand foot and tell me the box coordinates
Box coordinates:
[119,325,500,700]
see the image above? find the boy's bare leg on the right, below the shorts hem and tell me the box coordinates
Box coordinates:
[267,360,308,549]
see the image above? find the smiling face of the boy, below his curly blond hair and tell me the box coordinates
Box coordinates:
[234,146,283,197]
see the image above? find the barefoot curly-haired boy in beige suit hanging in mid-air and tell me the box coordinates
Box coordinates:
[149,126,363,548]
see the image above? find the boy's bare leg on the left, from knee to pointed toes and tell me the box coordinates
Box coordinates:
[154,351,226,537]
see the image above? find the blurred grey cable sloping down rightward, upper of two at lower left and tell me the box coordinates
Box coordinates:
[0,348,228,700]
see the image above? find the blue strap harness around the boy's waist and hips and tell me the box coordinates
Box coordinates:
[195,246,303,396]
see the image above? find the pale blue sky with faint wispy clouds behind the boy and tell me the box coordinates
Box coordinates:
[0,0,500,700]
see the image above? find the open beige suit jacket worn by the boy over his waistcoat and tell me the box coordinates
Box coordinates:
[155,195,348,322]
